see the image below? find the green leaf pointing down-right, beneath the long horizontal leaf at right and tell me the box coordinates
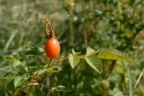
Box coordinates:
[85,55,102,73]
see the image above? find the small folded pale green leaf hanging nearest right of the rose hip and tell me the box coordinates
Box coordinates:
[69,54,80,68]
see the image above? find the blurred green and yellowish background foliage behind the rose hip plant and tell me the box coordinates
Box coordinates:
[0,0,144,96]
